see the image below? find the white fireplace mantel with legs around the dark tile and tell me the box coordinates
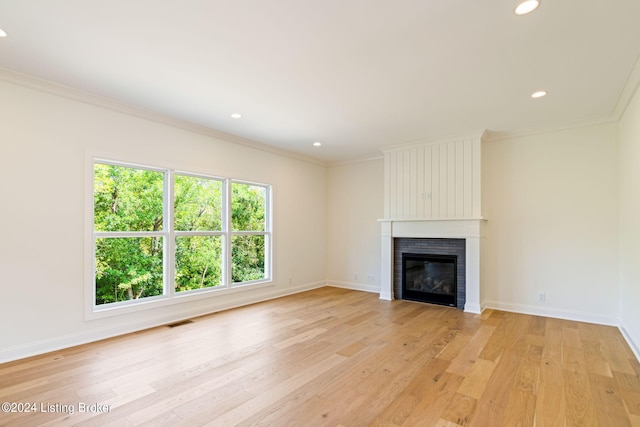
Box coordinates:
[378,218,486,313]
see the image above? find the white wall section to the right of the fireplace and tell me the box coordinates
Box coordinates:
[482,123,620,324]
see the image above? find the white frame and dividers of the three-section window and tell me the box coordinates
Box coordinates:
[85,156,273,320]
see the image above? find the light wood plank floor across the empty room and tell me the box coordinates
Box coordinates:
[0,287,640,427]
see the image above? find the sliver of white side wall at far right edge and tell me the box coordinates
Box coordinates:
[619,83,640,358]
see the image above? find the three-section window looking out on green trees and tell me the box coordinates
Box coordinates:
[92,161,271,310]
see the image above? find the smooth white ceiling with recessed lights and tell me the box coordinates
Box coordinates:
[0,0,640,163]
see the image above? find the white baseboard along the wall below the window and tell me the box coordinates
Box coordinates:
[0,281,327,363]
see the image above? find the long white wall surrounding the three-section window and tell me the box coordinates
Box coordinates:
[0,81,327,362]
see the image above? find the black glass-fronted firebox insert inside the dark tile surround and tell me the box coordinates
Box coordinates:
[400,253,458,307]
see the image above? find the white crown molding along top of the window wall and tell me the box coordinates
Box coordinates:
[0,67,327,167]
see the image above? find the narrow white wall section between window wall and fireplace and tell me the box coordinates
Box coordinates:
[327,159,384,292]
